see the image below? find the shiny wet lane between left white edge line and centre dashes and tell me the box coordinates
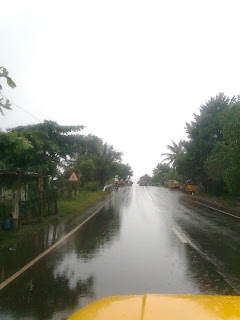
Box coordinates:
[0,187,236,320]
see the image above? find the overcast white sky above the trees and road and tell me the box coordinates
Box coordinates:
[0,0,240,179]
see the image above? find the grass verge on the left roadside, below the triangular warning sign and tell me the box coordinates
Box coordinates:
[0,191,106,248]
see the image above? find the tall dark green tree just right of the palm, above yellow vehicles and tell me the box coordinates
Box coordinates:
[180,93,230,192]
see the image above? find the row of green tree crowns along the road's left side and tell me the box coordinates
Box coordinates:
[0,121,133,188]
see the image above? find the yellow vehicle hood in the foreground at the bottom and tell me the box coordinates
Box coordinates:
[68,294,240,320]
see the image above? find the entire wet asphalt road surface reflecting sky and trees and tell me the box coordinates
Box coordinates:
[0,186,240,320]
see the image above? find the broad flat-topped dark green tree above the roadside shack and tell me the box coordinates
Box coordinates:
[1,121,83,176]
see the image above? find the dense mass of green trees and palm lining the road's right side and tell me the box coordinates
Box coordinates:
[152,93,240,197]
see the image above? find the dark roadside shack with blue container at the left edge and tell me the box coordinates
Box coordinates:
[0,170,42,229]
